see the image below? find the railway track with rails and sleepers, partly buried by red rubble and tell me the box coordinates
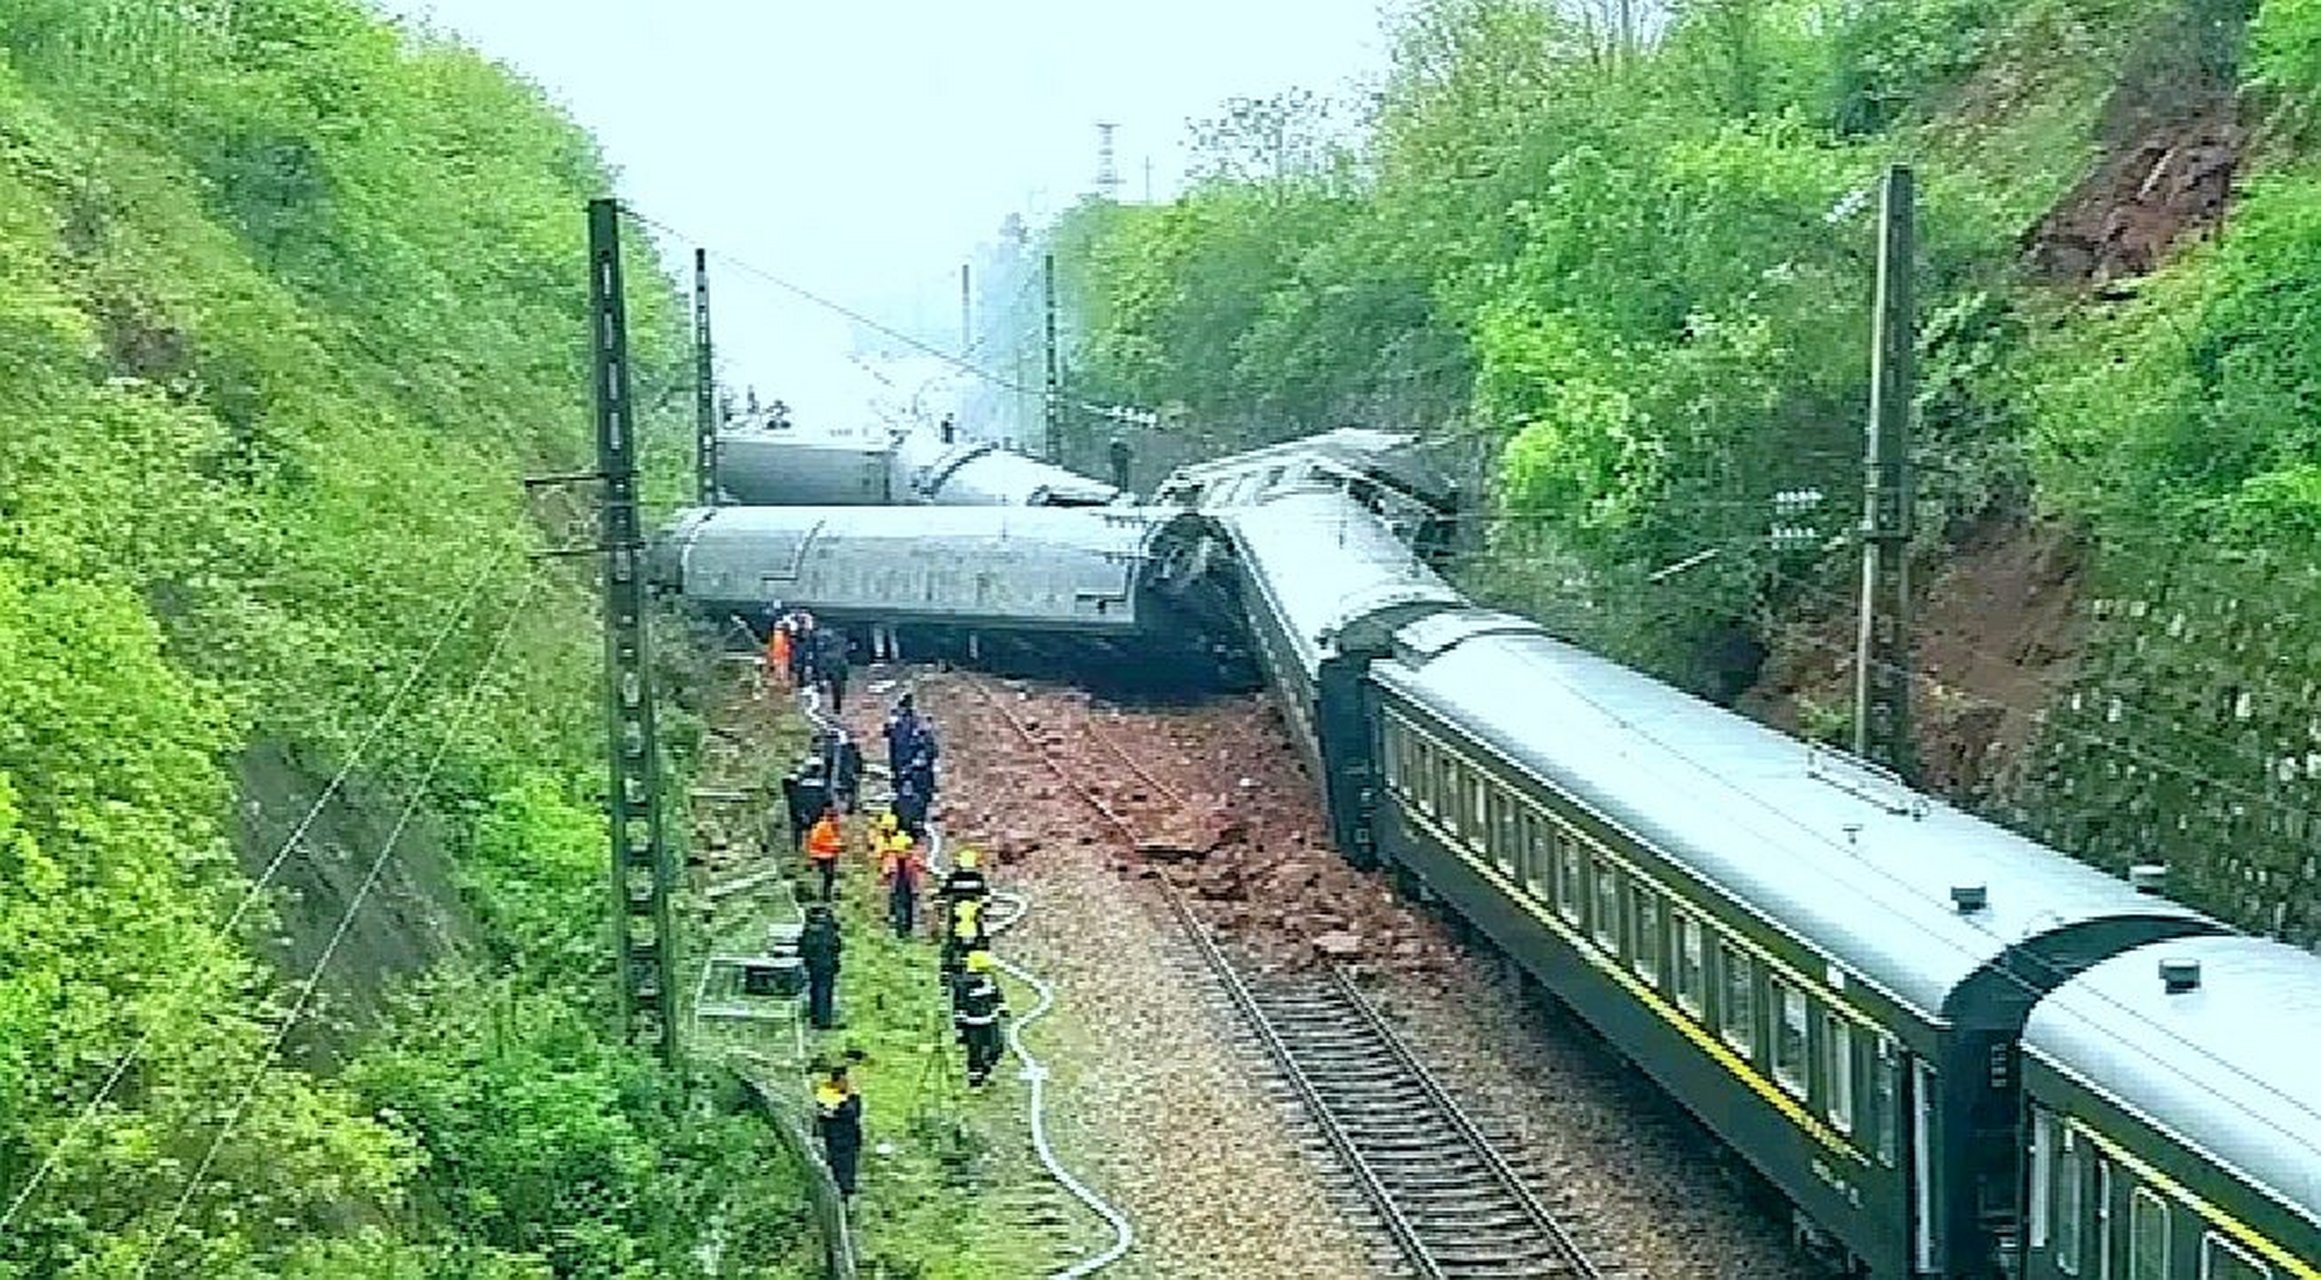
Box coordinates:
[968,681,1604,1278]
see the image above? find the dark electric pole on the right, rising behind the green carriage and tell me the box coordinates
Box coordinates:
[1854,165,1917,778]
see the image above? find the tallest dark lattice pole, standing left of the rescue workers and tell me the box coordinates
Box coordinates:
[587,200,678,1064]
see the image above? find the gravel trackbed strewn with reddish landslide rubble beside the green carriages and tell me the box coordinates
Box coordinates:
[919,674,1813,1278]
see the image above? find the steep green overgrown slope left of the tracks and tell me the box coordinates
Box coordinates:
[0,0,794,1275]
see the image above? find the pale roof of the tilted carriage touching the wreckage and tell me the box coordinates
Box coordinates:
[1219,486,1465,674]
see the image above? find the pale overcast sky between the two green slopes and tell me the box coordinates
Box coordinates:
[378,0,1383,420]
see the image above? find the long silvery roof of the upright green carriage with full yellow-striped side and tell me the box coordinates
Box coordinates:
[1374,613,2214,1020]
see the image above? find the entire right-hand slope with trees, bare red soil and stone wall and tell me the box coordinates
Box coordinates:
[1051,0,2321,939]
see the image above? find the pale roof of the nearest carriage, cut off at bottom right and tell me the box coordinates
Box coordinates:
[2024,936,2321,1227]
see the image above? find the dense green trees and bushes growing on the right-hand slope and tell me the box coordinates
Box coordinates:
[1058,0,2321,685]
